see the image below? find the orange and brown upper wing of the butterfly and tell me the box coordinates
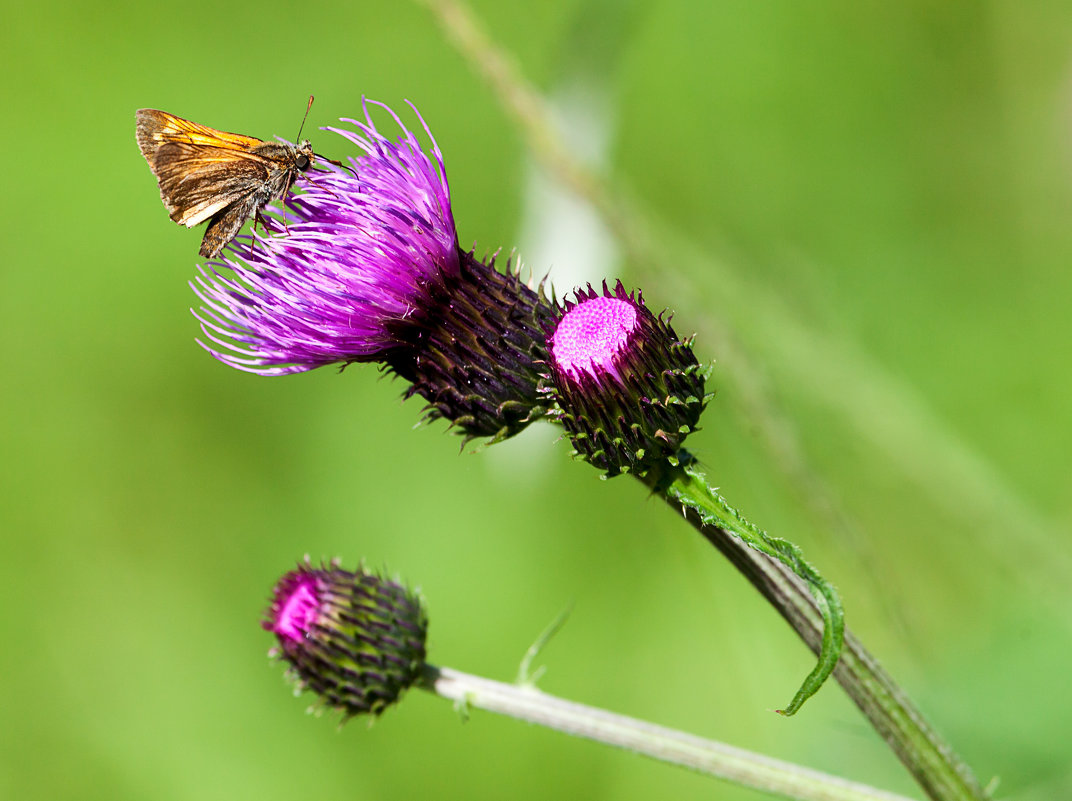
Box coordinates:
[137,108,272,227]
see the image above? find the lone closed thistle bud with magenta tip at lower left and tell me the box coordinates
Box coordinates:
[263,562,428,717]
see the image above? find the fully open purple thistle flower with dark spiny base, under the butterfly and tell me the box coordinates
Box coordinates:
[192,104,550,437]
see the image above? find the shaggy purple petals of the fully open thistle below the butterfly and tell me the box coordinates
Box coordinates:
[192,104,459,375]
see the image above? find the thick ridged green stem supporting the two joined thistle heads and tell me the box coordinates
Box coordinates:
[644,466,987,801]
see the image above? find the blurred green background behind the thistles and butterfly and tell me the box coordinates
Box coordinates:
[0,0,1072,801]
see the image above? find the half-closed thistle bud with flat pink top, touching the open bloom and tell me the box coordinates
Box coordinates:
[542,281,710,475]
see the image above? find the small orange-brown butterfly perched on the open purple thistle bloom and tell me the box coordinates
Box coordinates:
[137,98,342,258]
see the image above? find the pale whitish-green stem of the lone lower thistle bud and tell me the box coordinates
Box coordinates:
[419,665,911,801]
